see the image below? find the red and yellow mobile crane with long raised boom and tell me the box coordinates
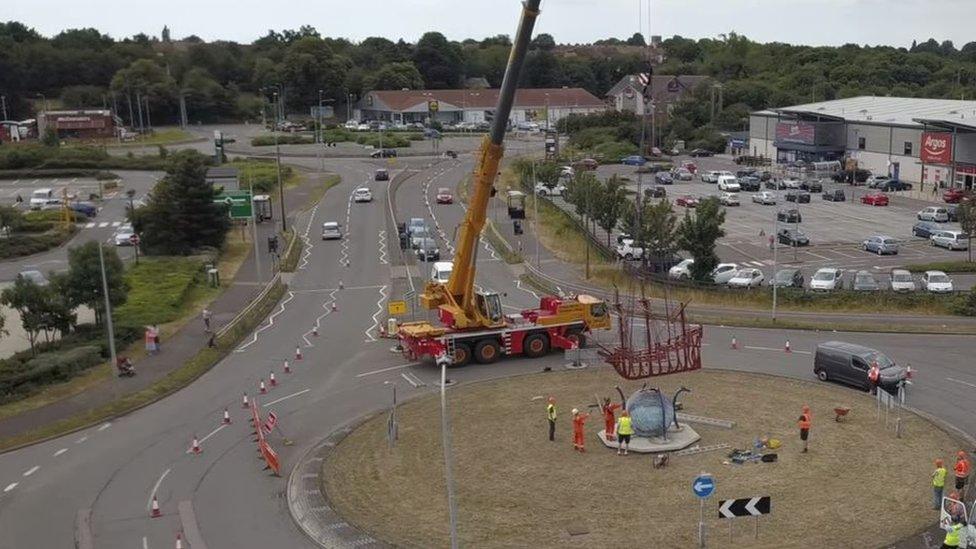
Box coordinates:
[397,0,610,366]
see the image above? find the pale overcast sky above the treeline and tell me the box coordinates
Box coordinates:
[7,0,976,48]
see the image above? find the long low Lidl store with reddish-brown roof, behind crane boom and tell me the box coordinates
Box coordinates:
[356,88,607,127]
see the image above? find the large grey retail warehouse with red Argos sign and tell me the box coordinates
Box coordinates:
[748,97,976,190]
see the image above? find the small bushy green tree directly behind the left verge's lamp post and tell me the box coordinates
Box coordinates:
[61,241,129,325]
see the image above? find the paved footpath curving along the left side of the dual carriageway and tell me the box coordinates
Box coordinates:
[0,173,326,440]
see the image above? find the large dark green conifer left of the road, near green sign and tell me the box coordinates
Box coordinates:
[129,151,230,255]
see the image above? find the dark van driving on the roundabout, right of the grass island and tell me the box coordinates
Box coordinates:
[813,341,907,394]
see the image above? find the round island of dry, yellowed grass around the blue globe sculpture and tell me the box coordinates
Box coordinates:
[321,368,958,548]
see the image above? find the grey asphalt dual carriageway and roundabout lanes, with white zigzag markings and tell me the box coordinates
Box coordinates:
[0,148,976,549]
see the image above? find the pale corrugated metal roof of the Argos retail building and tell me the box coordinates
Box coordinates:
[754,96,976,127]
